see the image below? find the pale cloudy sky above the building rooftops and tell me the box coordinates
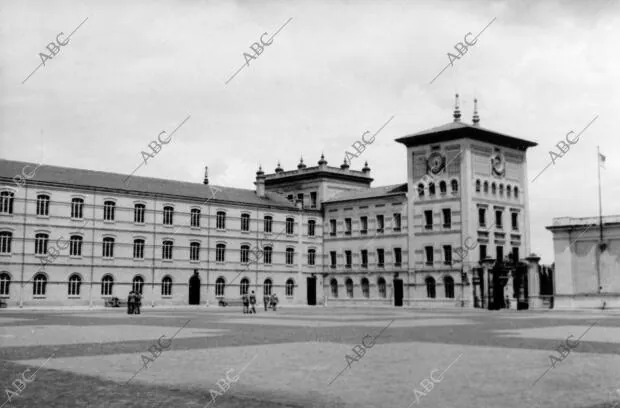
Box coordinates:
[0,0,620,263]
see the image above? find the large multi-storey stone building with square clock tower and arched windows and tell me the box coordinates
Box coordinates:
[0,97,539,308]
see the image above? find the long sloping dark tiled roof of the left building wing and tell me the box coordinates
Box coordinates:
[0,159,296,209]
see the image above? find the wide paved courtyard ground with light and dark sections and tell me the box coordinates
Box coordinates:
[0,307,620,408]
